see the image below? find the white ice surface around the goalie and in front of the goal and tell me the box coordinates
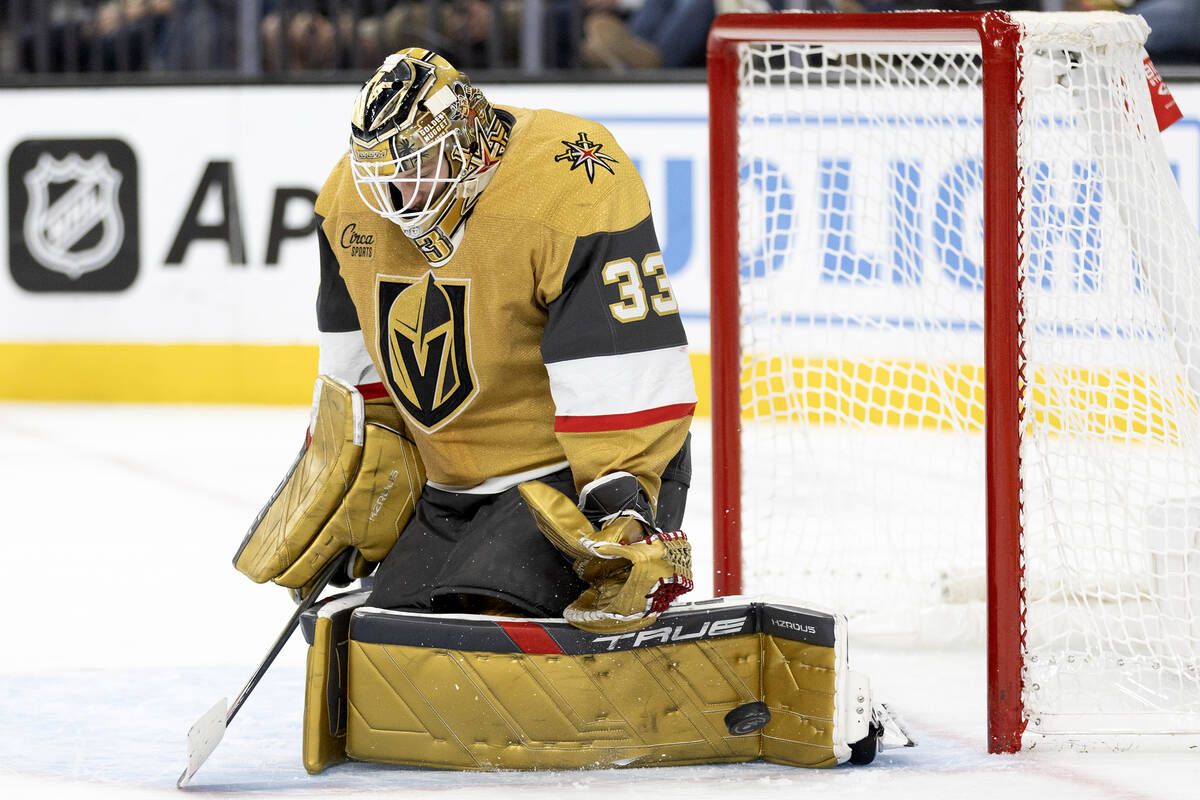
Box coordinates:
[0,403,1200,800]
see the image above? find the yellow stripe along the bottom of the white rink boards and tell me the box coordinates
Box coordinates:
[0,343,1180,444]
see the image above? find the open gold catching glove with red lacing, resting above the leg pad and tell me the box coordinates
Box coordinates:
[520,473,692,633]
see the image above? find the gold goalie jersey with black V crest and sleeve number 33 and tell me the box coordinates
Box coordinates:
[316,107,696,499]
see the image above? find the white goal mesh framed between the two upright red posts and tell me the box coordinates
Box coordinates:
[739,38,984,637]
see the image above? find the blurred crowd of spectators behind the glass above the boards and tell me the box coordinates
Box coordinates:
[0,0,1200,76]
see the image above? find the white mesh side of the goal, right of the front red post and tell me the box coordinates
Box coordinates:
[1016,14,1200,732]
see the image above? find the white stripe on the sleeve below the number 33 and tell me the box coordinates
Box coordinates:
[546,347,696,416]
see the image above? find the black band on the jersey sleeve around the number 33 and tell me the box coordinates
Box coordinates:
[541,216,688,363]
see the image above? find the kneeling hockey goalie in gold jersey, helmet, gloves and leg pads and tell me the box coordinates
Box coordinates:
[201,48,904,772]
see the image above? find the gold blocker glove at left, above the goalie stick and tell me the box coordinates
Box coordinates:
[234,375,425,589]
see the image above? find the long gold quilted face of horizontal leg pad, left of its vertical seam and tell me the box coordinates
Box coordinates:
[347,637,758,770]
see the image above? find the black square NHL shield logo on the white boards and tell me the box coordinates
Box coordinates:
[8,139,138,291]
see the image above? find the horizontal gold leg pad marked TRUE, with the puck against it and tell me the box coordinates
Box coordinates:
[346,601,845,770]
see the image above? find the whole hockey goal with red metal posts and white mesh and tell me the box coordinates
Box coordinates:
[709,12,1200,751]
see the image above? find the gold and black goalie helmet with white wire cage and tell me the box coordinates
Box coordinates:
[350,48,508,265]
